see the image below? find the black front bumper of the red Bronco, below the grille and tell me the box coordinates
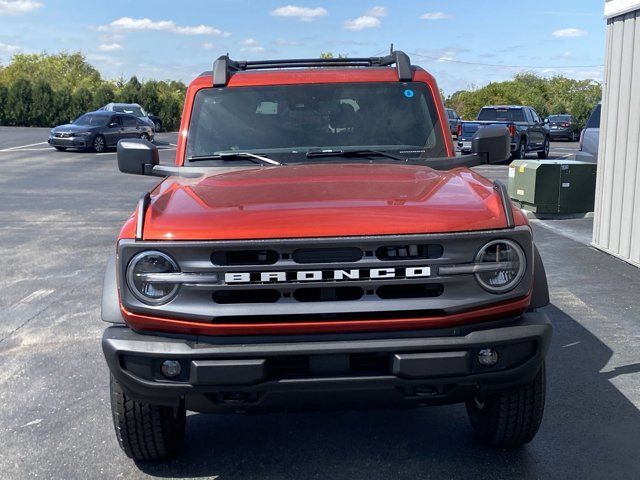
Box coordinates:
[102,312,551,412]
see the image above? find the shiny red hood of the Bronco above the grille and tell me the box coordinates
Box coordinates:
[141,164,506,240]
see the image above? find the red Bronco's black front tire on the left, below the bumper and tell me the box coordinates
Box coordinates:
[110,377,186,460]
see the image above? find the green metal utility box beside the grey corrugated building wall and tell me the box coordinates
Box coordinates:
[509,160,596,214]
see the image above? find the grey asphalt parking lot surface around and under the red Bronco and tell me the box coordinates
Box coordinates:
[0,127,640,480]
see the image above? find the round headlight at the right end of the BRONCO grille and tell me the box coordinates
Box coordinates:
[475,240,526,293]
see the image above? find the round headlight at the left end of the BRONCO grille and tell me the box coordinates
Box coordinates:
[127,250,179,305]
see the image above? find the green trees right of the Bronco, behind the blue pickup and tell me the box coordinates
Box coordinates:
[444,73,602,128]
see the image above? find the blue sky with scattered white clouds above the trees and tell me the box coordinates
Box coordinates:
[0,0,605,94]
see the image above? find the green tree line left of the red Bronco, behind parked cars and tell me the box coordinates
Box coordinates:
[0,52,186,130]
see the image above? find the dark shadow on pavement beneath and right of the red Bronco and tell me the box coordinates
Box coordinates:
[138,306,640,479]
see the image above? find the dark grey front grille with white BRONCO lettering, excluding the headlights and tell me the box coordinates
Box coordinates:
[118,227,532,324]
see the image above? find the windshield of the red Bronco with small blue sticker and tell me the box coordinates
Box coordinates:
[187,82,448,161]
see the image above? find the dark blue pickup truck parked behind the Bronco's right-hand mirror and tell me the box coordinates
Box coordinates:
[458,105,551,159]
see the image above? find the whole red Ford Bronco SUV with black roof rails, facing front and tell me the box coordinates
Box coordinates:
[102,51,551,460]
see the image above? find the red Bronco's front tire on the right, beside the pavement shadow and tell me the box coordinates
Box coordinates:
[467,363,546,447]
